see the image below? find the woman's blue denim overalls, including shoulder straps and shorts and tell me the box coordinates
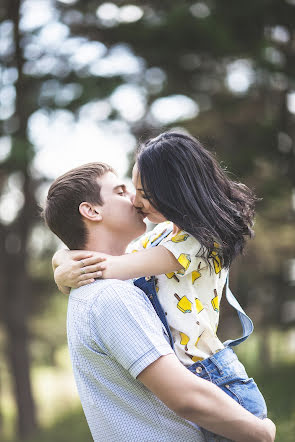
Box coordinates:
[134,228,267,442]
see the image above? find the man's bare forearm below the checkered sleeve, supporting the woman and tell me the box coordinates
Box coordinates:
[137,354,275,442]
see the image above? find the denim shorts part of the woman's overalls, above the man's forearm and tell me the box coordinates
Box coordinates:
[188,347,267,442]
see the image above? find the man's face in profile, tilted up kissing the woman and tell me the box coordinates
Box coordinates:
[98,172,146,240]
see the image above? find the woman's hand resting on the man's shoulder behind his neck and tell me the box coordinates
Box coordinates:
[52,250,107,294]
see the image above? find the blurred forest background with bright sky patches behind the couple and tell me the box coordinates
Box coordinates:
[0,0,295,442]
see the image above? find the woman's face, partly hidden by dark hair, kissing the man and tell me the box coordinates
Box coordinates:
[132,163,166,224]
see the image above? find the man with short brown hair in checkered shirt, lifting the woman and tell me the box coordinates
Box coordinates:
[44,163,275,442]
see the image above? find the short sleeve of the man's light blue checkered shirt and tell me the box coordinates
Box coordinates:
[90,280,173,378]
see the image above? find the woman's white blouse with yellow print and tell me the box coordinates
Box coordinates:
[131,221,228,366]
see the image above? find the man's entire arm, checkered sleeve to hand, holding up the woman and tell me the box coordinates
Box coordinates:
[90,280,275,442]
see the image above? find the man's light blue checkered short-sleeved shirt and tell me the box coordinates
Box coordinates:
[67,280,204,442]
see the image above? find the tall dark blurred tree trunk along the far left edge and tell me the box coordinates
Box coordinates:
[1,0,37,439]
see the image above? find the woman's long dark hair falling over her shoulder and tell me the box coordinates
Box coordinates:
[137,132,256,267]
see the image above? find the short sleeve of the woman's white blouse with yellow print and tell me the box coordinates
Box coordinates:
[161,231,208,277]
